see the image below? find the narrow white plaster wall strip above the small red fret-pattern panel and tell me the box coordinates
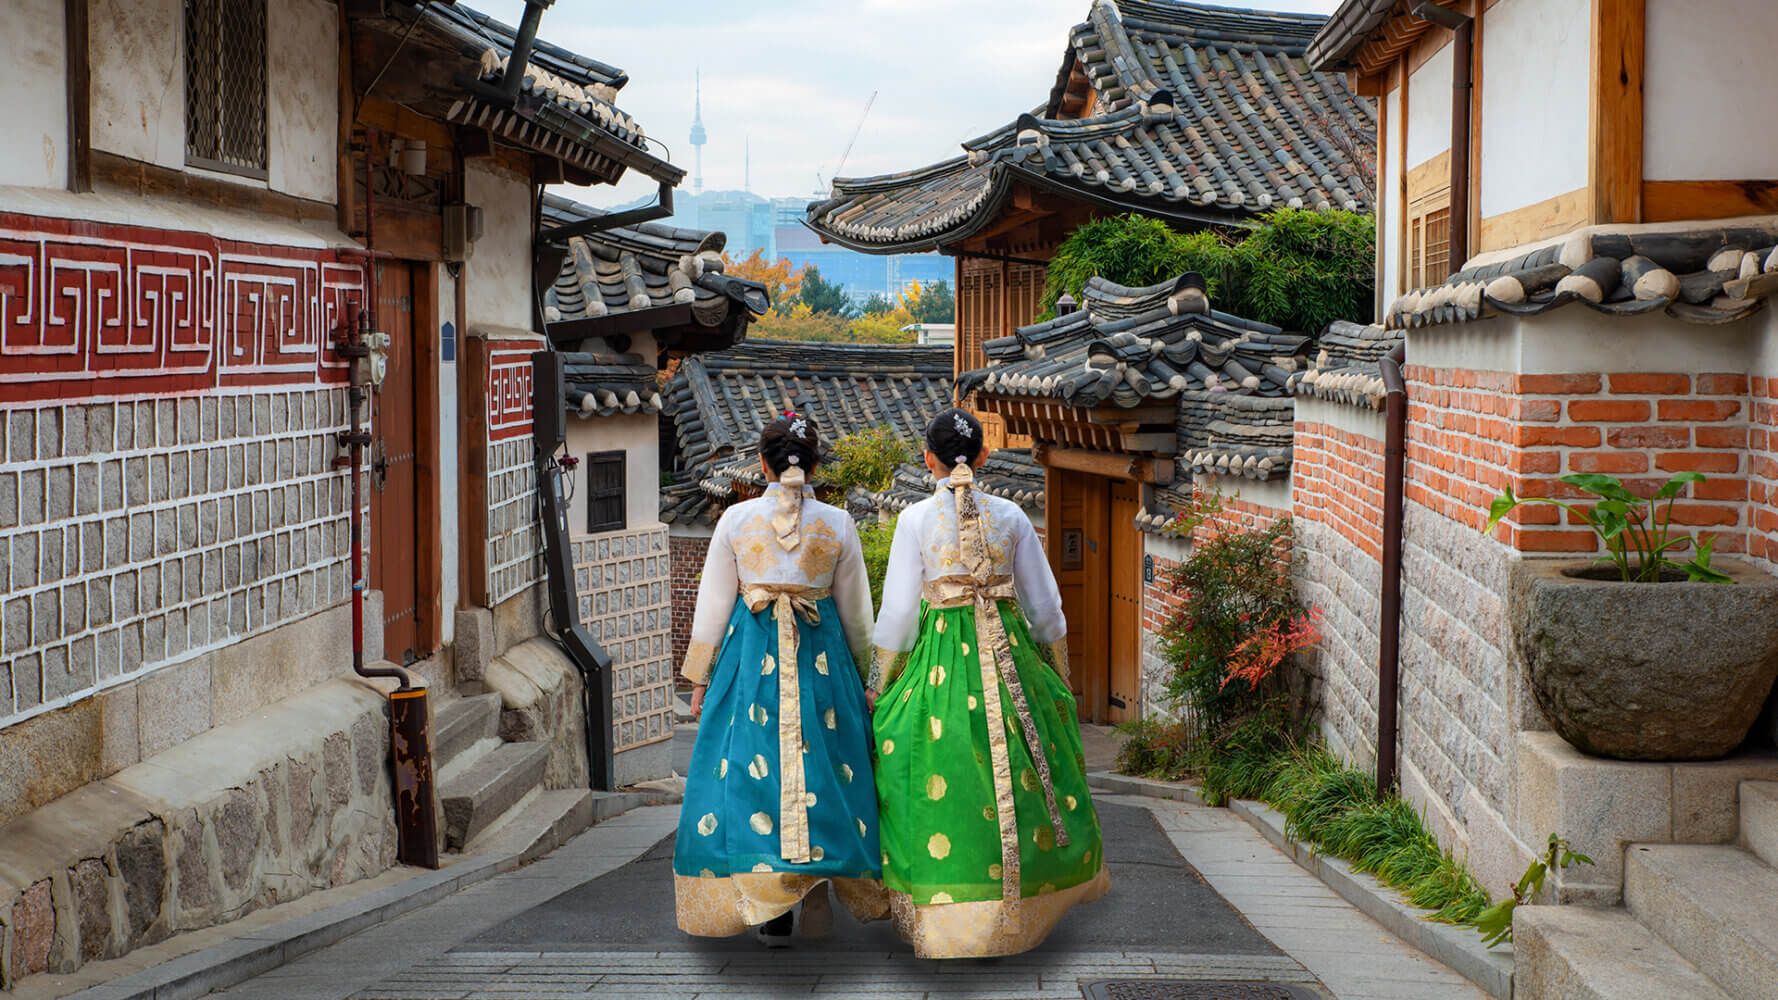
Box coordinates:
[464,160,532,329]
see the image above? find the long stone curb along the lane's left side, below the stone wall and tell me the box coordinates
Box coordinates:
[68,792,667,1000]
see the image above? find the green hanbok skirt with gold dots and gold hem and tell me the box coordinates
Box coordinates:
[873,600,1109,957]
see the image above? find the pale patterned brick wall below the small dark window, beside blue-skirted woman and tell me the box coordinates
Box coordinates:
[573,525,674,751]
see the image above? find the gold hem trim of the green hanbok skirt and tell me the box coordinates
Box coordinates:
[885,868,1111,959]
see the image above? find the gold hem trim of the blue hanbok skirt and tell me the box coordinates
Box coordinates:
[672,872,889,938]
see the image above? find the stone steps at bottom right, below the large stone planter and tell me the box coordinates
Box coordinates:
[1513,781,1778,1000]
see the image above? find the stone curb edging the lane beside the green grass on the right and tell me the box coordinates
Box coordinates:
[1229,799,1513,1000]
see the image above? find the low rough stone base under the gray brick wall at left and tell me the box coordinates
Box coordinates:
[0,680,395,988]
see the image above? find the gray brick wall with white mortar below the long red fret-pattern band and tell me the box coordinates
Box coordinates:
[0,388,350,728]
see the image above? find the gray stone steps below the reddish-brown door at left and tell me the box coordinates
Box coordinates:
[432,694,576,854]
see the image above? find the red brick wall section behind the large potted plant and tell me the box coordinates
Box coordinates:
[1408,365,1750,553]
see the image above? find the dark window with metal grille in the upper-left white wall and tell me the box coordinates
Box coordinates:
[185,0,265,178]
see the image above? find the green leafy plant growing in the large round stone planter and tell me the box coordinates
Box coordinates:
[1483,472,1734,584]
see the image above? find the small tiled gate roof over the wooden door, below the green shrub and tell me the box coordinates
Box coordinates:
[957,274,1314,479]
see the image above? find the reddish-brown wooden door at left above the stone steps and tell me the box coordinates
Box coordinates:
[368,260,427,664]
